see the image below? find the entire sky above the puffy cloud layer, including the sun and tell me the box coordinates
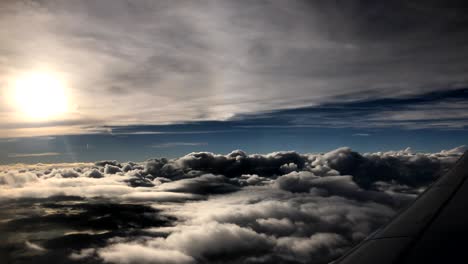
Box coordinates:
[0,0,468,164]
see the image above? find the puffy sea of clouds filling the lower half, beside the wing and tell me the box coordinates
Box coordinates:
[0,146,465,264]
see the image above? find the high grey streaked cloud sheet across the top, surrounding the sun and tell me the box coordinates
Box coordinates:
[0,0,468,137]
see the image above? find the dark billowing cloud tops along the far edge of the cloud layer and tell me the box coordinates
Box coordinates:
[145,148,454,192]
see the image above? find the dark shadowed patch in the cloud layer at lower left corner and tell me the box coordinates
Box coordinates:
[0,200,175,263]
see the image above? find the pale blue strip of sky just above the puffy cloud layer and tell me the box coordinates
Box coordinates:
[0,124,468,163]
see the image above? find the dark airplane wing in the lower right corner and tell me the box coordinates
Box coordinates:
[333,152,468,264]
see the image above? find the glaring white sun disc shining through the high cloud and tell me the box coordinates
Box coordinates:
[12,73,68,120]
